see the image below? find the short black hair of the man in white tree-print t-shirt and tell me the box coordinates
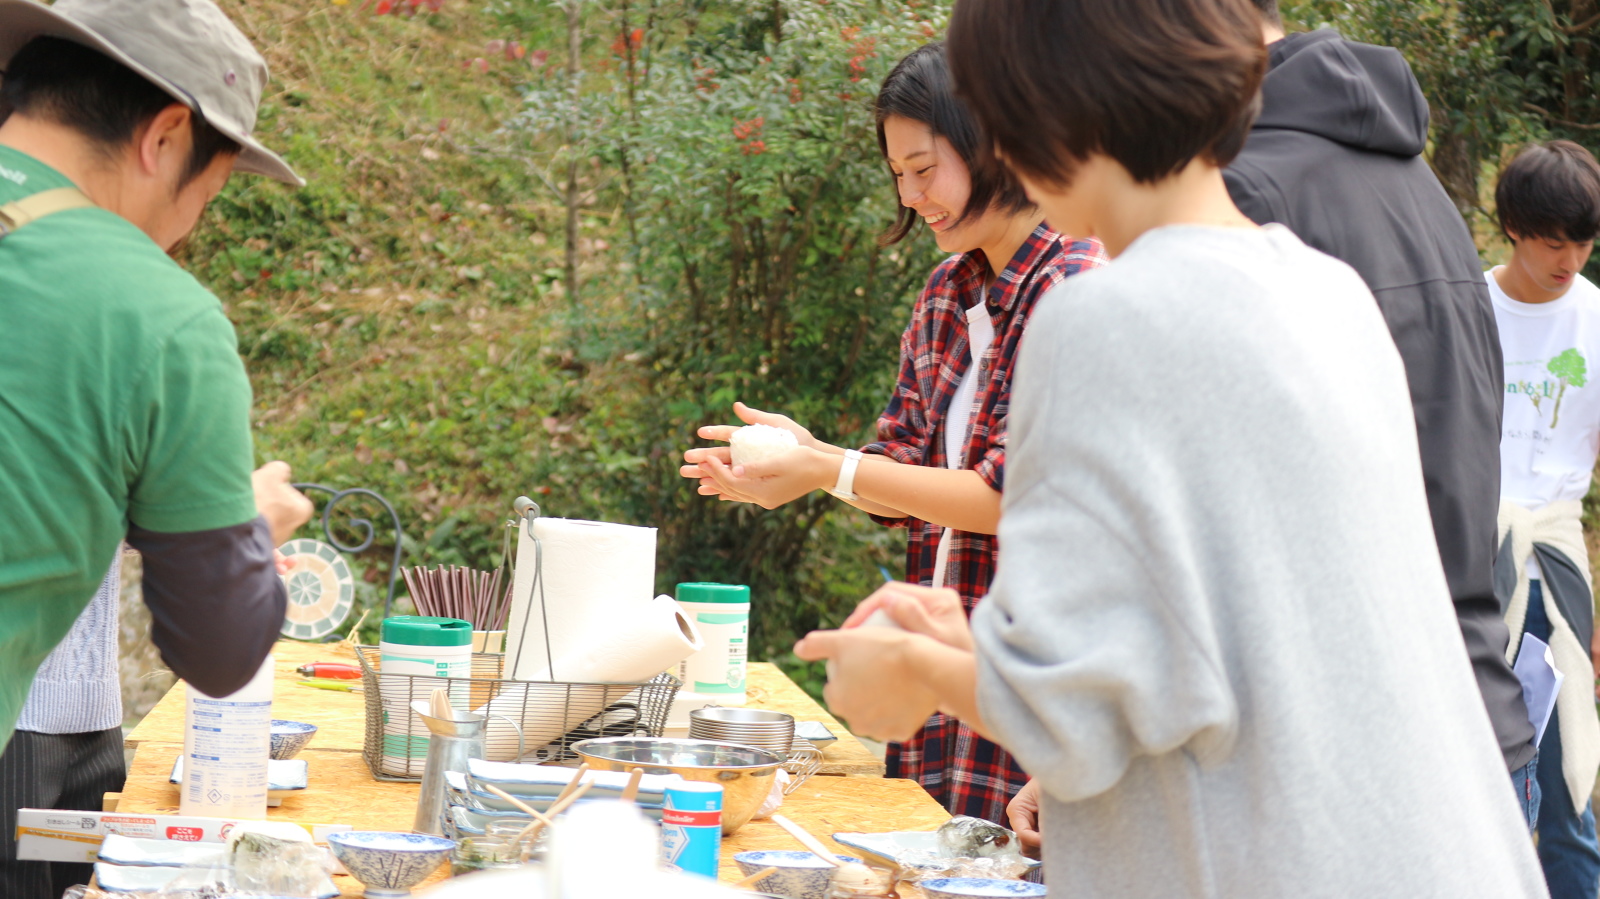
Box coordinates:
[1494,141,1600,243]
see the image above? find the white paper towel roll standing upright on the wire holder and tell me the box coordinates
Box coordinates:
[506,518,656,681]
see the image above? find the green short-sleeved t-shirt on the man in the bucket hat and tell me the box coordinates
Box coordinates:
[0,147,256,747]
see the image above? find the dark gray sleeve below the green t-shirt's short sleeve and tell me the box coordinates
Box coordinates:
[128,515,288,696]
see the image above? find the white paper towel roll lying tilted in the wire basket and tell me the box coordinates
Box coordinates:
[483,597,704,761]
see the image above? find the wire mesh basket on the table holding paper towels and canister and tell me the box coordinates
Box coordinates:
[355,646,682,781]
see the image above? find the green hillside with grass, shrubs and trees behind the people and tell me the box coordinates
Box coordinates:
[196,0,1600,688]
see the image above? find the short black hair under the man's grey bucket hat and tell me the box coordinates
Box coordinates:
[0,37,243,187]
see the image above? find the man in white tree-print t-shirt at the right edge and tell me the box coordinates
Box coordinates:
[1485,141,1600,899]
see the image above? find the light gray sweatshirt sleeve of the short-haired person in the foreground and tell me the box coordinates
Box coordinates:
[973,275,1238,801]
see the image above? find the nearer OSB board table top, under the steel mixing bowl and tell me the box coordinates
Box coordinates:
[128,742,950,899]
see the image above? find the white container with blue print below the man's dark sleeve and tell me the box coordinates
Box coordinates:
[178,656,272,819]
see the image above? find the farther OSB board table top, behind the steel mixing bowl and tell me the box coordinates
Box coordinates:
[125,640,885,777]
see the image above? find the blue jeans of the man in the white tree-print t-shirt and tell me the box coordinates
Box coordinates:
[1523,581,1600,899]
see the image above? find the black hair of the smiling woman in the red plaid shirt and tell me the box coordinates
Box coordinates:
[874,42,1034,246]
